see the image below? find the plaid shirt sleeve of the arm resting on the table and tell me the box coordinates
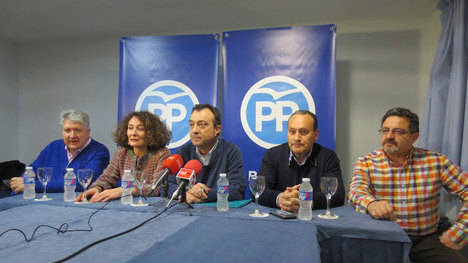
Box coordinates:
[348,157,376,213]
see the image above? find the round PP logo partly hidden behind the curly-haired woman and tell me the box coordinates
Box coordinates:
[135,80,198,149]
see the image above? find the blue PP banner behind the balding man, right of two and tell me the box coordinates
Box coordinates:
[222,25,336,198]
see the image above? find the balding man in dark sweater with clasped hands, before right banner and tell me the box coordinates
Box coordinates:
[258,110,345,213]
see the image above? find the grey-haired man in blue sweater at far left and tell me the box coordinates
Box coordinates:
[10,110,109,193]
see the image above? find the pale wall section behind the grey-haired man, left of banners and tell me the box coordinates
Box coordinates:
[18,39,119,163]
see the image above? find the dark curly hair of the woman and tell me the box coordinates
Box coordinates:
[114,111,171,153]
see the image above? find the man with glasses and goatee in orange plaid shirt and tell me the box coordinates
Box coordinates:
[349,108,468,262]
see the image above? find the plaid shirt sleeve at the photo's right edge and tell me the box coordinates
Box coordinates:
[440,156,468,249]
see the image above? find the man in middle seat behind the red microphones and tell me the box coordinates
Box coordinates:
[168,104,245,204]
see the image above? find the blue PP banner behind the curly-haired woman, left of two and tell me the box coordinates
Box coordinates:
[118,34,219,149]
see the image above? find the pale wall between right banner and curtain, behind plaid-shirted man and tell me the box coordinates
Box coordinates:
[336,16,440,192]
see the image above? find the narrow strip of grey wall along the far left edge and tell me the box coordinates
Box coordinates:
[0,40,18,161]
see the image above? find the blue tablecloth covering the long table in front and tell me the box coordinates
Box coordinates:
[0,194,411,262]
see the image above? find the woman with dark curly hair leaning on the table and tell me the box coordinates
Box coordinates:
[75,111,171,202]
